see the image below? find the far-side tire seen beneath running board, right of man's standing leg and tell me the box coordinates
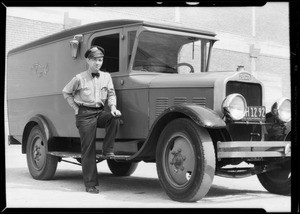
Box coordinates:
[107,159,138,176]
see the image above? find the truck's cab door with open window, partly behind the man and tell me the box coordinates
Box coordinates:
[88,26,148,139]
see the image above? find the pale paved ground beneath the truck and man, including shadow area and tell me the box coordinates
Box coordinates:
[5,144,291,212]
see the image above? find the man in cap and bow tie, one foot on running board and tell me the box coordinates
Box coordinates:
[62,46,121,193]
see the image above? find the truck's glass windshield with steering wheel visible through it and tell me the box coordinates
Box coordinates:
[133,31,210,73]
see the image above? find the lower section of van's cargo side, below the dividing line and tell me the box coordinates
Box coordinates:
[8,94,79,137]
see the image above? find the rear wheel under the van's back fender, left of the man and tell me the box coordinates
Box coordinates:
[26,126,58,180]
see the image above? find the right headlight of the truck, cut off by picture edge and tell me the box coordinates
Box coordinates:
[271,97,291,123]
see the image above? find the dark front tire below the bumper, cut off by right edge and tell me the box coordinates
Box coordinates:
[257,134,291,195]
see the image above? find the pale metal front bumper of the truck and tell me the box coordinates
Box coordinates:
[217,141,291,159]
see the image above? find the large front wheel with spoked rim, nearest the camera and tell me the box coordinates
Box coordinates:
[156,118,216,202]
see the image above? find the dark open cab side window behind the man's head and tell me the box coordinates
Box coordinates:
[92,33,120,73]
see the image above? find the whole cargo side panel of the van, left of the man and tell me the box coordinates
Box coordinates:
[7,37,86,137]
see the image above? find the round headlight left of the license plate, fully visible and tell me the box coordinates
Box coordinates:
[222,94,247,120]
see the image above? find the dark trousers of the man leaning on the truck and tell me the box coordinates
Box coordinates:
[76,106,120,187]
